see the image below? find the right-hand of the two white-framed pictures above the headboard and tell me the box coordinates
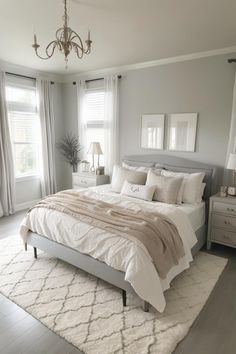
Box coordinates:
[167,113,198,152]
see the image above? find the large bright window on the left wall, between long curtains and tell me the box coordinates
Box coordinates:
[6,75,41,178]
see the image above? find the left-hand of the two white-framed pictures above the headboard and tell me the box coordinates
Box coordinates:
[141,113,165,150]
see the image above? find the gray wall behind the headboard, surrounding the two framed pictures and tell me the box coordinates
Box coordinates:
[120,55,235,166]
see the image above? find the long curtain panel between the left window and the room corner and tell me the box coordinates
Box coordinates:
[36,79,57,196]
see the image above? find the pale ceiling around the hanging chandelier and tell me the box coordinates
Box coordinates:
[0,0,236,74]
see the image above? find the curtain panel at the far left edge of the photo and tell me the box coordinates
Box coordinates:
[0,71,15,216]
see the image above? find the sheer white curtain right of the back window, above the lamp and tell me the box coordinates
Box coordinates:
[104,75,119,174]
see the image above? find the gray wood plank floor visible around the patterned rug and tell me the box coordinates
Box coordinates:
[0,213,236,354]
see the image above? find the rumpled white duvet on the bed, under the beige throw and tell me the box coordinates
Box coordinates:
[19,185,197,312]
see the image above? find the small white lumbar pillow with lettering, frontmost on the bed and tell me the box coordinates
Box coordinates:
[121,181,156,202]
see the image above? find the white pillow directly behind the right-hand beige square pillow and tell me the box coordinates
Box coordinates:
[161,170,205,204]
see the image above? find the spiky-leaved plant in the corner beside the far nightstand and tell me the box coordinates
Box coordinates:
[56,133,82,172]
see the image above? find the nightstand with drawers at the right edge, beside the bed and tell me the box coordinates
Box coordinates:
[207,194,236,250]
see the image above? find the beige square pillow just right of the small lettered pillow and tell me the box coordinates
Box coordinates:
[146,171,183,204]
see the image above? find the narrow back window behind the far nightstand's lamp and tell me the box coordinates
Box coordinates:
[84,80,105,165]
